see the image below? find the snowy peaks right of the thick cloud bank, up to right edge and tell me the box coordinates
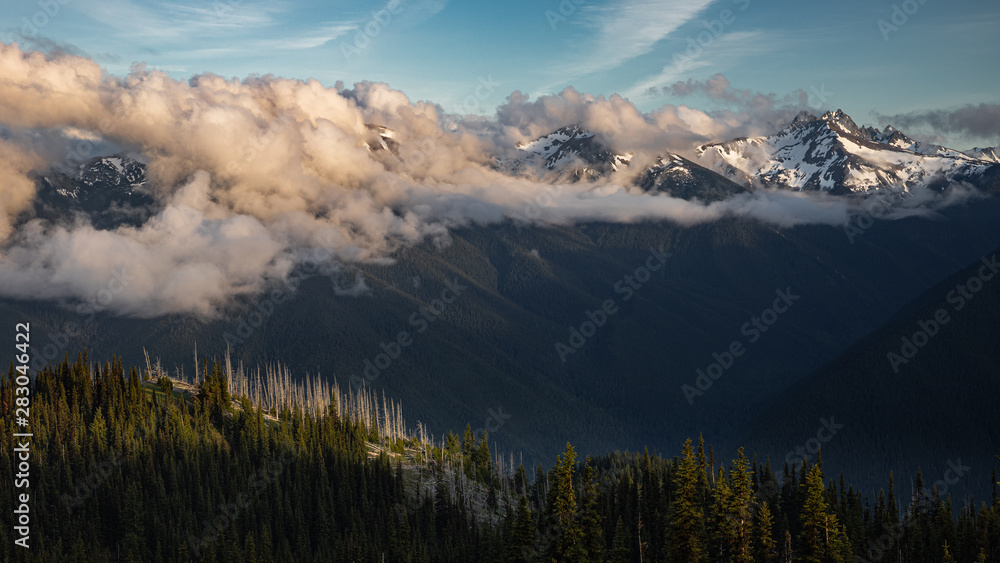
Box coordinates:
[488,110,1000,201]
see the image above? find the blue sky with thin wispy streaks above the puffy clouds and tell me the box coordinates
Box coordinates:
[0,0,1000,148]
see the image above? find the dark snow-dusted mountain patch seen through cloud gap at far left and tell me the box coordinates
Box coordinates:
[35,154,155,229]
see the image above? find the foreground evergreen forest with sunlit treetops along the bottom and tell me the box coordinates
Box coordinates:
[0,354,1000,563]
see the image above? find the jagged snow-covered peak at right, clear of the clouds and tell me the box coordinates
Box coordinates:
[697,110,996,194]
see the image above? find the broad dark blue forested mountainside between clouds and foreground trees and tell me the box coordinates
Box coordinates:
[7,194,1000,479]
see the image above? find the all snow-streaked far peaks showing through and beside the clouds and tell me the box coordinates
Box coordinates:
[35,110,1000,227]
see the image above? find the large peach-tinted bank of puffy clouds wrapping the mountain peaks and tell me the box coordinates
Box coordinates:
[0,43,976,317]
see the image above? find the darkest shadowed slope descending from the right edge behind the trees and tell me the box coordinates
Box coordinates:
[744,248,1000,499]
